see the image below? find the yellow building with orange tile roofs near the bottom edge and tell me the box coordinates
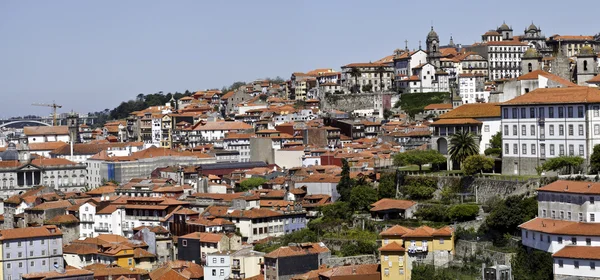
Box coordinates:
[379,225,454,280]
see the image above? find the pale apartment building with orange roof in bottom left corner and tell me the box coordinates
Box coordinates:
[0,226,64,280]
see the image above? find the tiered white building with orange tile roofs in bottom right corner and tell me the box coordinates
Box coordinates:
[519,180,600,279]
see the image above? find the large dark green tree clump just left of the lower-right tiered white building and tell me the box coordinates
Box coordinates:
[479,195,537,246]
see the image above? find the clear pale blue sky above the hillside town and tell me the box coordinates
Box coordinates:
[0,0,600,118]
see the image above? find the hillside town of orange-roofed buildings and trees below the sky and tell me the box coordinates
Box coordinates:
[0,22,600,280]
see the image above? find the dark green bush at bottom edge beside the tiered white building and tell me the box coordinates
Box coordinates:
[511,247,553,280]
